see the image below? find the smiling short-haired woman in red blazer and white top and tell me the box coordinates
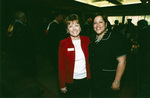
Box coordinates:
[58,14,90,98]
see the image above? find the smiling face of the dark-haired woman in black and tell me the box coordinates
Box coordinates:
[93,16,107,35]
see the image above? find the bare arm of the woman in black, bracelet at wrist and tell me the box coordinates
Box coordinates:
[112,55,126,90]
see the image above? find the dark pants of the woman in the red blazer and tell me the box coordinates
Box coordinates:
[61,78,90,98]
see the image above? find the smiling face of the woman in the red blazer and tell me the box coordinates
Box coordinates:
[67,20,81,38]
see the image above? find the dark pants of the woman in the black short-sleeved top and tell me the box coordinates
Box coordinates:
[91,71,119,98]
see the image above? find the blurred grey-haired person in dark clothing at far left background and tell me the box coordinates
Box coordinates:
[7,11,36,77]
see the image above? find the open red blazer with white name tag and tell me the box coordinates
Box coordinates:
[58,36,91,88]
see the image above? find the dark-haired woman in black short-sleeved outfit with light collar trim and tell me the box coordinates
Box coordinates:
[89,14,126,98]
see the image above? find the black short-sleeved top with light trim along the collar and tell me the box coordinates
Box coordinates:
[89,32,126,73]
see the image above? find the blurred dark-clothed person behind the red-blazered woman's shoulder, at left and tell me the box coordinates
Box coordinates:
[45,13,62,73]
